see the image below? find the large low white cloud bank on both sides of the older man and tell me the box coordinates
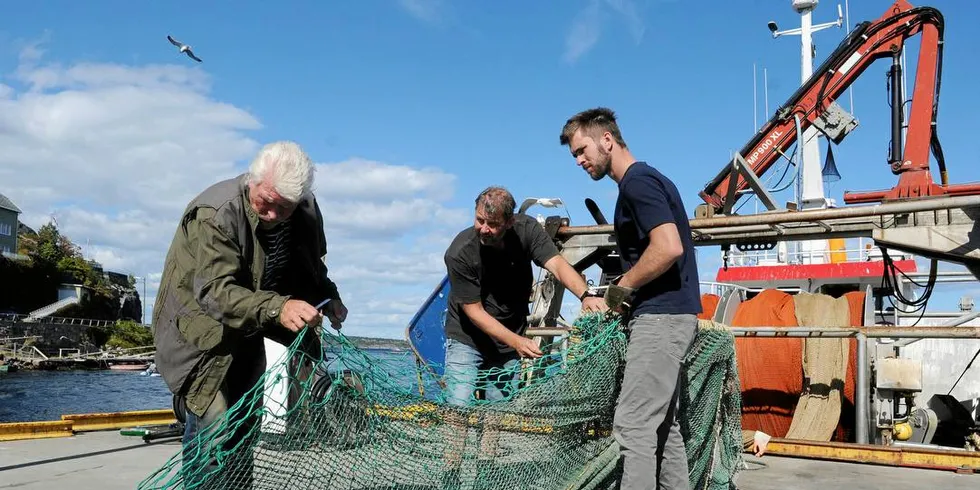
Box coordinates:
[0,43,470,338]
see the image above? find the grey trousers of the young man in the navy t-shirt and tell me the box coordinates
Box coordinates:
[613,314,697,490]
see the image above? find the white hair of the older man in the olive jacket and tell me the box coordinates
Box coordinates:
[248,141,315,203]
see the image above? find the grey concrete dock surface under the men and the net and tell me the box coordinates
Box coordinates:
[0,430,980,490]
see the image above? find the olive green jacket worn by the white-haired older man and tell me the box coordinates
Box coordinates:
[152,174,340,416]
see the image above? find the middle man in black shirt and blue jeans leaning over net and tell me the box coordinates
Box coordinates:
[444,187,607,405]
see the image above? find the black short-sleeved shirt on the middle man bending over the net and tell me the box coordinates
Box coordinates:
[444,214,558,357]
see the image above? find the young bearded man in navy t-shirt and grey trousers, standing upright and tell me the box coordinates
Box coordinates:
[560,108,701,490]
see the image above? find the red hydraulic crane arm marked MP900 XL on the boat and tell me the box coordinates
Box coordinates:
[699,0,980,213]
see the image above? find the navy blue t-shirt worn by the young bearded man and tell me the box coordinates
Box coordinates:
[613,162,701,315]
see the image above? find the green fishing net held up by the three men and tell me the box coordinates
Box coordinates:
[140,315,742,490]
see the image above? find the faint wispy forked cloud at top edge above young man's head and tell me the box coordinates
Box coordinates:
[563,0,645,63]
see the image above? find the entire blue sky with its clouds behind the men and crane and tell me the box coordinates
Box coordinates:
[0,0,980,338]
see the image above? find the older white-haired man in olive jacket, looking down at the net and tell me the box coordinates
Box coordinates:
[153,141,347,486]
